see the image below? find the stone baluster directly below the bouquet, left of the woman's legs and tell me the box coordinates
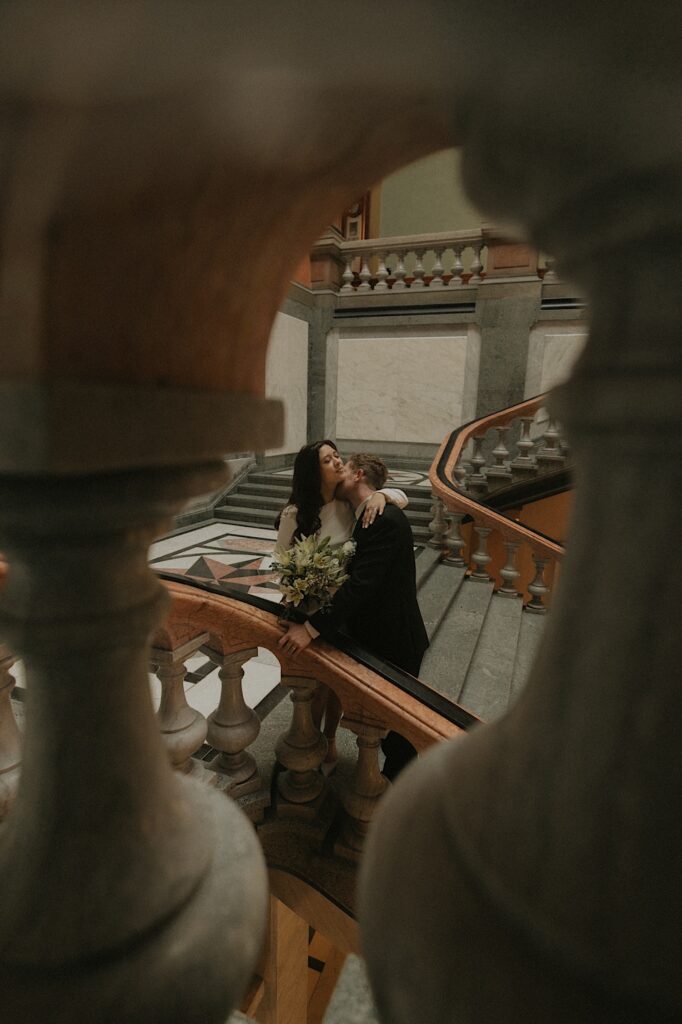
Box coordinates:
[274,676,327,817]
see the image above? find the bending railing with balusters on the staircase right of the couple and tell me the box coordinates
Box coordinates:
[429,395,568,613]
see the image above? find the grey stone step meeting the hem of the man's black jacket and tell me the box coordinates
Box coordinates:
[419,577,493,703]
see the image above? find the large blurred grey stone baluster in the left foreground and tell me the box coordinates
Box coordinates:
[0,462,267,1022]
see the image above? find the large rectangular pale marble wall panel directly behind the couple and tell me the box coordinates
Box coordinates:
[336,327,479,443]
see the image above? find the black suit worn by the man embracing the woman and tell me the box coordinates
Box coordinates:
[310,505,429,778]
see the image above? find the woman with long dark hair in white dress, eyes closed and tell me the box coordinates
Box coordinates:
[275,440,408,774]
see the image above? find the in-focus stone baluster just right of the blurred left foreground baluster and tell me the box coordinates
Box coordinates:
[151,633,208,772]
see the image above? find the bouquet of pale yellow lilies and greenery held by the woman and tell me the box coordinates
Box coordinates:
[272,535,355,612]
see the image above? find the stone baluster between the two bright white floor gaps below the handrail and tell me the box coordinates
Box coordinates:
[204,647,262,797]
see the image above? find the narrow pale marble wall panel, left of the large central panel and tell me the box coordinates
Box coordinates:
[265,313,308,455]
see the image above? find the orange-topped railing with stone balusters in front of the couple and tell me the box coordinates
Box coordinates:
[152,578,476,858]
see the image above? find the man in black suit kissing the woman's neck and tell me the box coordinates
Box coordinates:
[279,455,429,779]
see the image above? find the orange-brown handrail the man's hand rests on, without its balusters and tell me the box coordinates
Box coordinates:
[155,580,465,751]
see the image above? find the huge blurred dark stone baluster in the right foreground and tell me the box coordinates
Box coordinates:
[359,3,682,1024]
